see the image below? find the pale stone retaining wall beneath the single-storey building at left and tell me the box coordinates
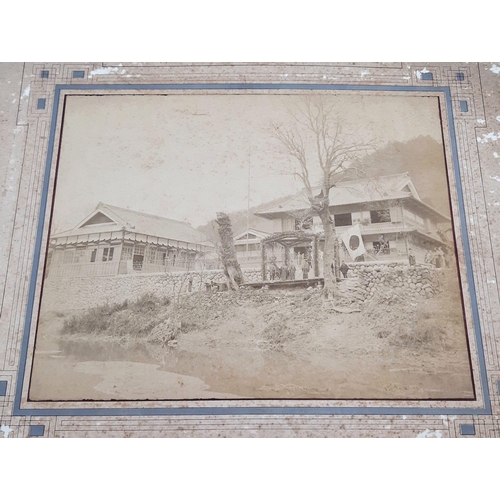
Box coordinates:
[42,269,261,311]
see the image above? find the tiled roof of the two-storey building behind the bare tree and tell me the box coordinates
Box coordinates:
[255,173,448,219]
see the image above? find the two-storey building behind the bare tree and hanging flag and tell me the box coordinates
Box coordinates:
[256,174,452,280]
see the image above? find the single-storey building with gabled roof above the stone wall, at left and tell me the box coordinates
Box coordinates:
[46,203,214,278]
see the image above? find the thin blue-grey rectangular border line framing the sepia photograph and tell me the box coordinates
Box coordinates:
[12,83,492,416]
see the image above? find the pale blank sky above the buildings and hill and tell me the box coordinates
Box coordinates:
[53,93,442,232]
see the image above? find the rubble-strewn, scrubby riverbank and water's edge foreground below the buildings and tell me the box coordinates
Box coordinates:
[34,278,473,399]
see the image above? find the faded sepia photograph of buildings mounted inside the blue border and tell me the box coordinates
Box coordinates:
[28,90,475,401]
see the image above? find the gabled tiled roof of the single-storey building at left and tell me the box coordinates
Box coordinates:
[52,203,213,246]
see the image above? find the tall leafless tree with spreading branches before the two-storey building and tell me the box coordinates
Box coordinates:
[271,95,373,299]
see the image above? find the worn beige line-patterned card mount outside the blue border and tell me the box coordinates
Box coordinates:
[0,63,500,437]
